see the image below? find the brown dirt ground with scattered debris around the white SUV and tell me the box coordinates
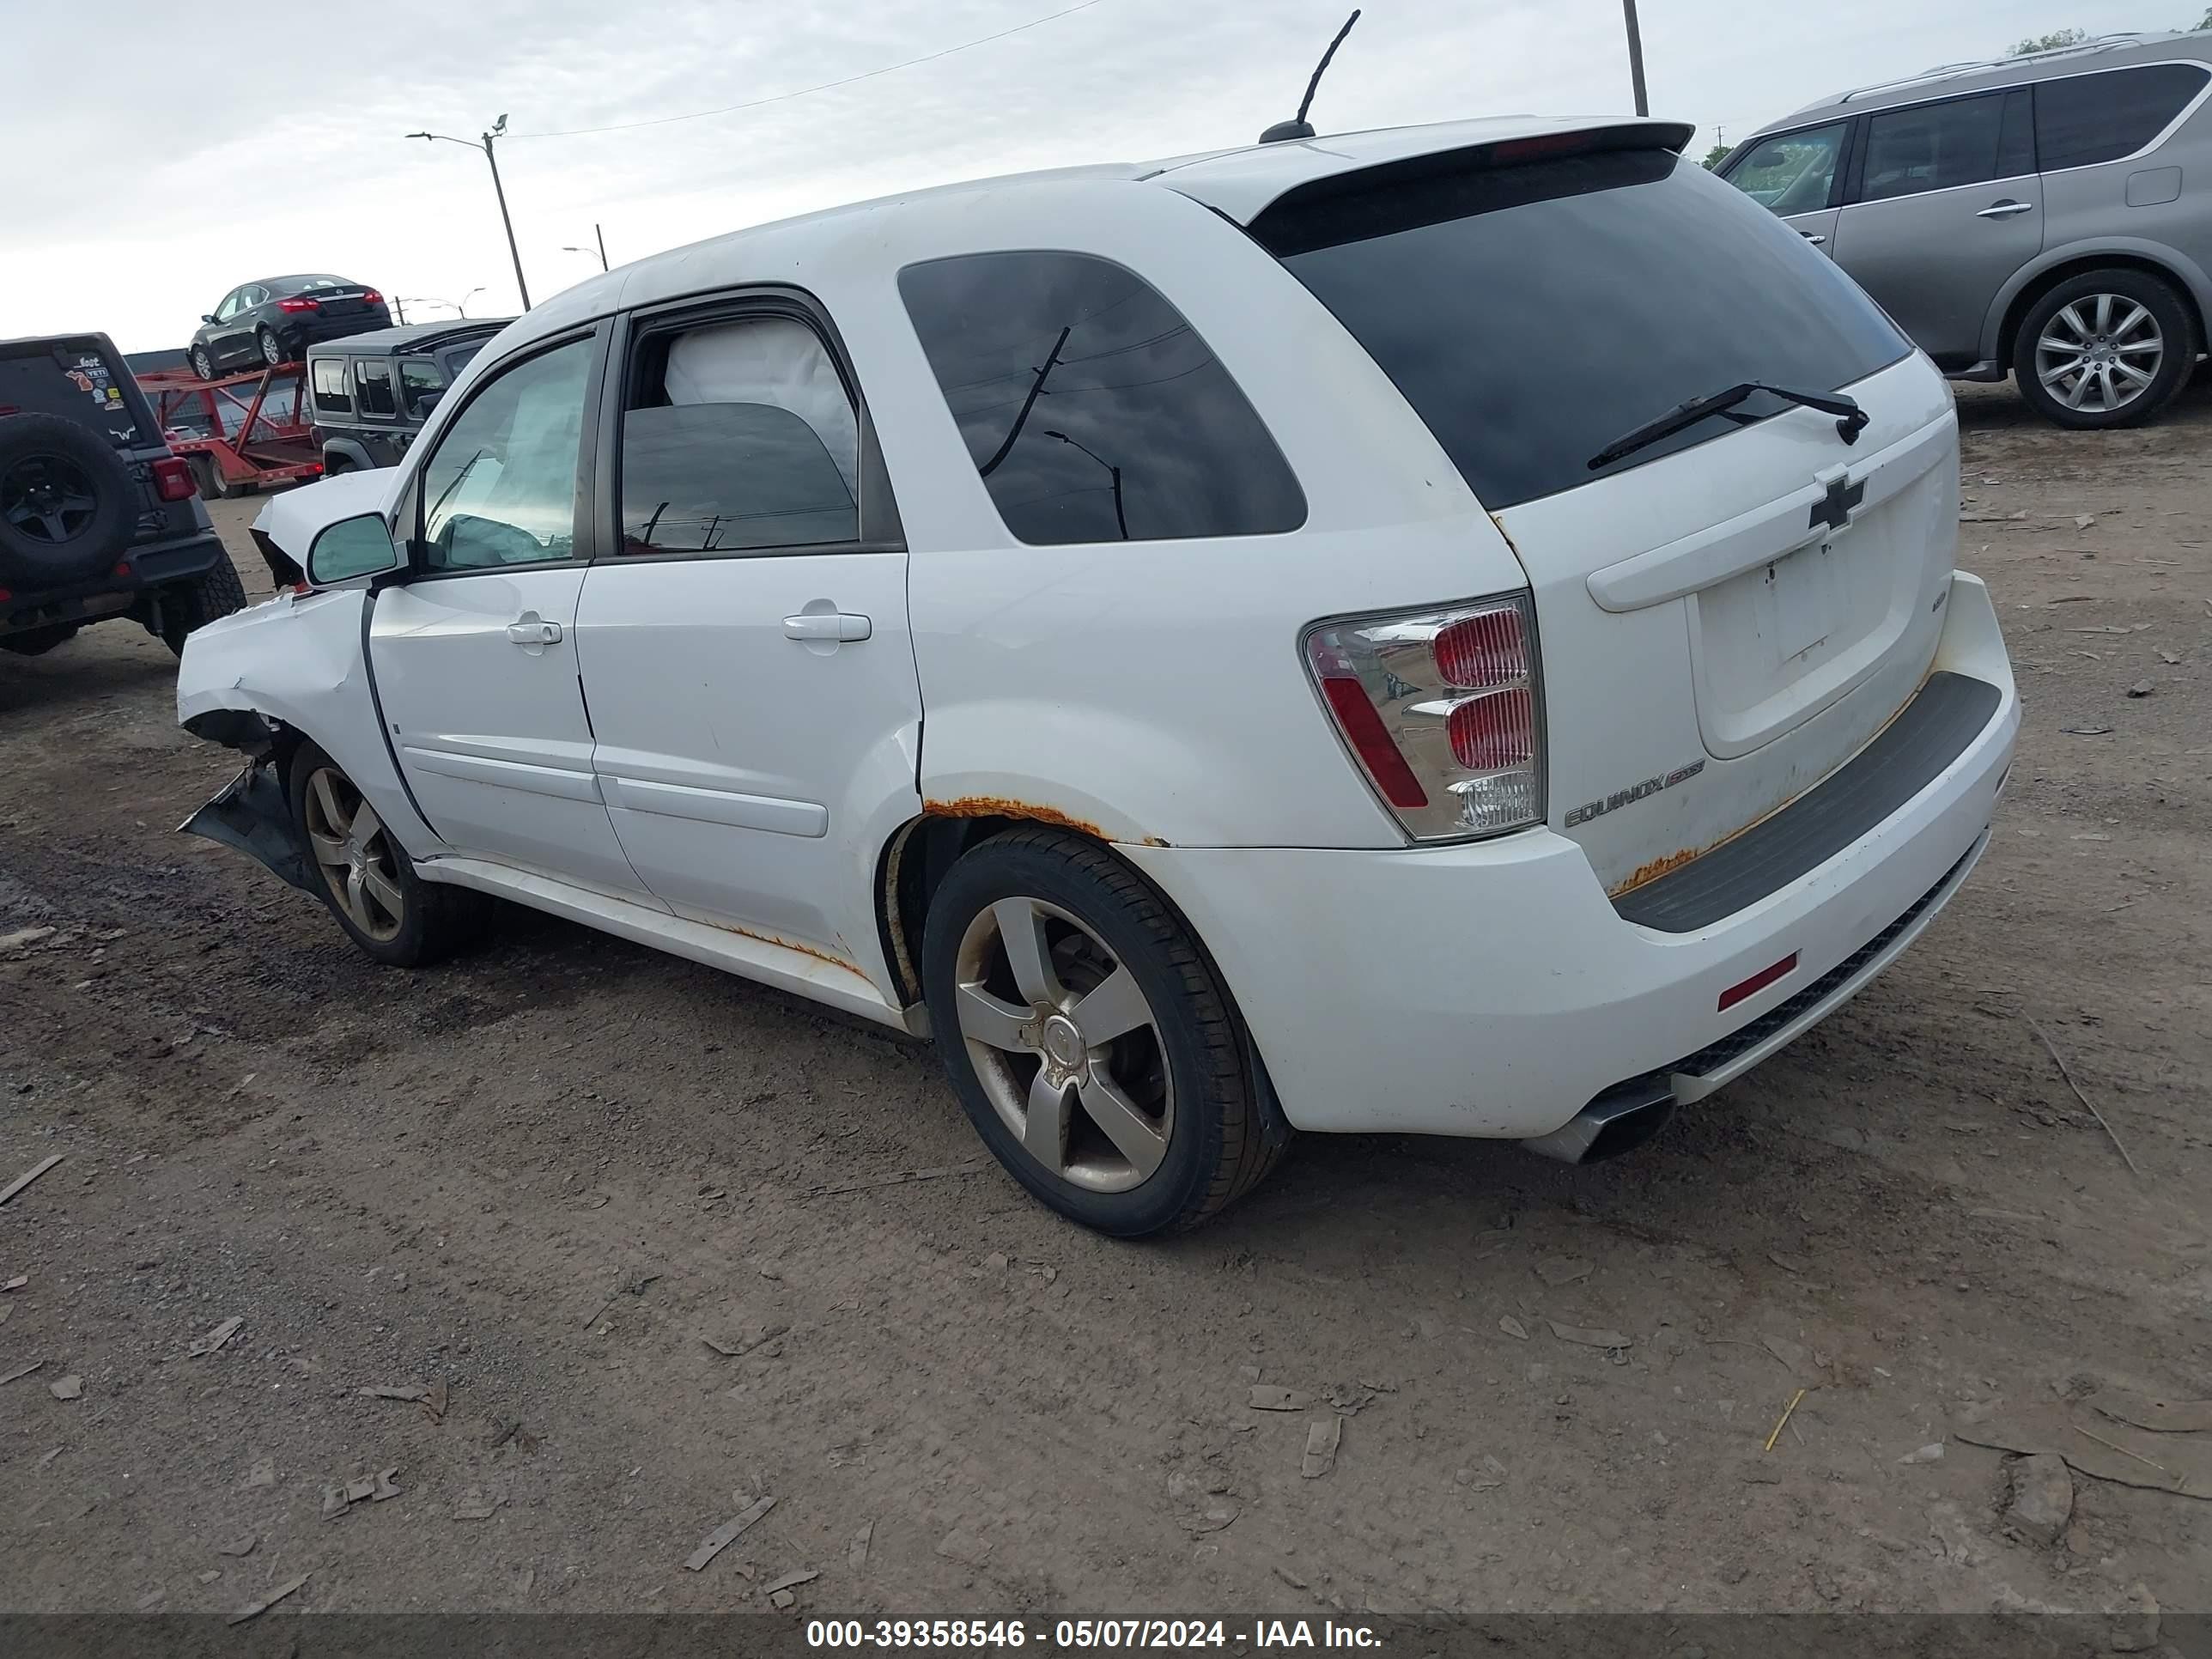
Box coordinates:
[0,376,2212,1620]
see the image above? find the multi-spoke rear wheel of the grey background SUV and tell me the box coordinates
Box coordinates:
[2013,270,2197,429]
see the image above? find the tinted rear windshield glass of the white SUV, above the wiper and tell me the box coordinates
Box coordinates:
[1252,150,1911,511]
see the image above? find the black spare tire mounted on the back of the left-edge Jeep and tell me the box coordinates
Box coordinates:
[0,414,139,588]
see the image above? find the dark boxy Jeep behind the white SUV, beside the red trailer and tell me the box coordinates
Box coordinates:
[307,316,514,477]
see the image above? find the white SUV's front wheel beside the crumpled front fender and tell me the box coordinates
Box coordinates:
[289,744,491,967]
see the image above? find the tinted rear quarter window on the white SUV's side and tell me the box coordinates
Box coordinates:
[898,252,1305,546]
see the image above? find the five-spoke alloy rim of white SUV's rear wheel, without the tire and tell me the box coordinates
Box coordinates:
[953,898,1175,1192]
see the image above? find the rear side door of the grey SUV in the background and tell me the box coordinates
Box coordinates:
[1832,88,2044,369]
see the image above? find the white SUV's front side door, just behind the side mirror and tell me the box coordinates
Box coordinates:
[369,337,641,898]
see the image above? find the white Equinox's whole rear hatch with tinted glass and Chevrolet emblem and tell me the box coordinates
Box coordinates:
[1252,138,1958,891]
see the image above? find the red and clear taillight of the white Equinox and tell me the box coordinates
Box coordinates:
[1305,592,1544,841]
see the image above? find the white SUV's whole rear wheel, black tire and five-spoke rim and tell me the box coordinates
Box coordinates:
[922,830,1287,1239]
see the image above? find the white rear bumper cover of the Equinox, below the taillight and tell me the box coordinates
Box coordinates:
[1124,575,2020,1139]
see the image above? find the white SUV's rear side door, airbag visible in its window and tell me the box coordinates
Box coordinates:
[577,301,922,963]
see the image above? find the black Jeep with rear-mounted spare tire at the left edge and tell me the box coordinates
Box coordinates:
[0,334,246,657]
